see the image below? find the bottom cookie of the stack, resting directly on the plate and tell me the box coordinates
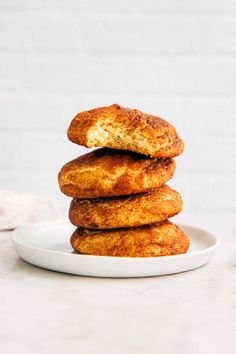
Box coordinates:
[71,221,189,257]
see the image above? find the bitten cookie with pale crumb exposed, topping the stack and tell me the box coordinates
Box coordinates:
[67,104,184,158]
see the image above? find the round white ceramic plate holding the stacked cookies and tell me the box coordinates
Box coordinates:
[12,220,219,277]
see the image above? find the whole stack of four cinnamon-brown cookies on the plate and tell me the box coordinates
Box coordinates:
[58,104,189,257]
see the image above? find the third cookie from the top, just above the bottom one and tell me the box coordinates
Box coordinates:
[69,185,183,229]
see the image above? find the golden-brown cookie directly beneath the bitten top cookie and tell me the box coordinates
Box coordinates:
[58,148,175,198]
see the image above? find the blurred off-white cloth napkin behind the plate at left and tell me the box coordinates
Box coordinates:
[0,190,61,230]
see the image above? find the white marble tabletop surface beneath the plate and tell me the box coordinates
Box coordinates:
[0,215,236,354]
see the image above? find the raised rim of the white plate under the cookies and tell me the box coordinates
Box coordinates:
[11,219,220,262]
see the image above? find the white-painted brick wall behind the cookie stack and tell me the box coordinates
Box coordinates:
[0,0,236,215]
